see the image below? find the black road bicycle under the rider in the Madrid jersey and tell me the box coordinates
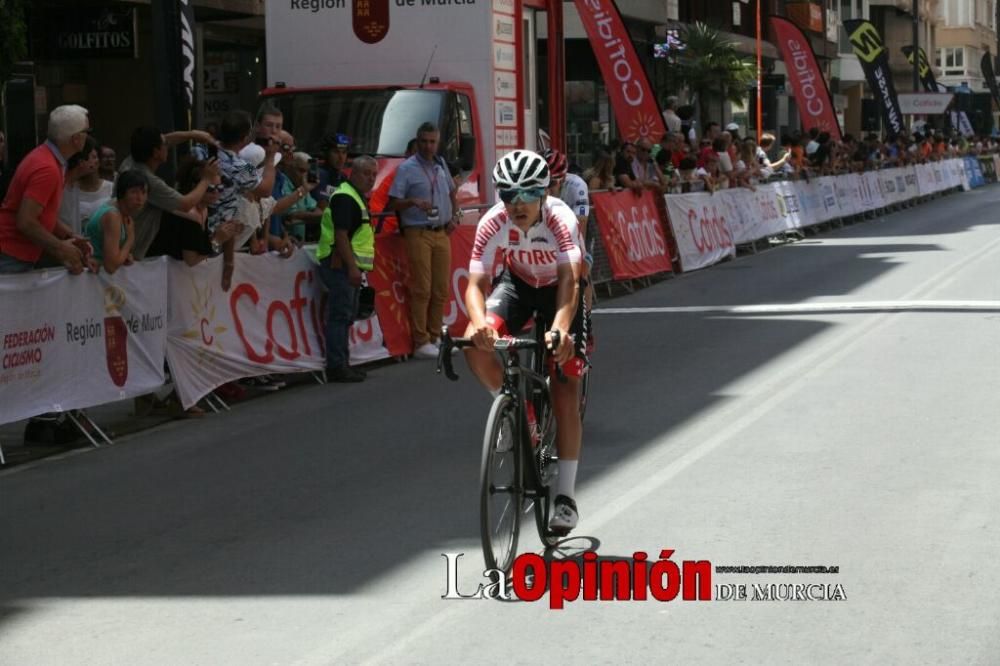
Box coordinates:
[437,325,566,573]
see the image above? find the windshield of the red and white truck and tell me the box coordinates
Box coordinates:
[264,89,445,157]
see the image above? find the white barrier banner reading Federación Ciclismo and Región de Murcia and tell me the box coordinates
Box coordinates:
[0,259,167,423]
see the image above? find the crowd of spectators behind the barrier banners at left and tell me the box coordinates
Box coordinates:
[0,105,388,413]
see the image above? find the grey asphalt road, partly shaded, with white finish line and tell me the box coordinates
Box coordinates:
[0,186,1000,666]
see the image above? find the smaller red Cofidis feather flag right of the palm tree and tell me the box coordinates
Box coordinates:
[771,16,841,141]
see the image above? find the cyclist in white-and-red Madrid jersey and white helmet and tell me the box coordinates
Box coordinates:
[465,150,587,533]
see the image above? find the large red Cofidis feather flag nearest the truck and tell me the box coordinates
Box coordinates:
[575,0,667,143]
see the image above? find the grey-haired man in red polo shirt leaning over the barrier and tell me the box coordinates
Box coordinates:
[0,104,95,275]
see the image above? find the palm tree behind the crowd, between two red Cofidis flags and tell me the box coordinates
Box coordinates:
[671,22,757,128]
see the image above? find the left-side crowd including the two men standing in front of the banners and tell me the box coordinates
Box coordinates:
[0,105,466,413]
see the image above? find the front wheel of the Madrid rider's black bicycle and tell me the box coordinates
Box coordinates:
[479,395,524,572]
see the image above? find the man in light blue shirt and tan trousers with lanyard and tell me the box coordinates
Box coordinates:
[387,123,459,358]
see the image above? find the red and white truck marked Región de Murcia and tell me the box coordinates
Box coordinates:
[261,0,562,209]
